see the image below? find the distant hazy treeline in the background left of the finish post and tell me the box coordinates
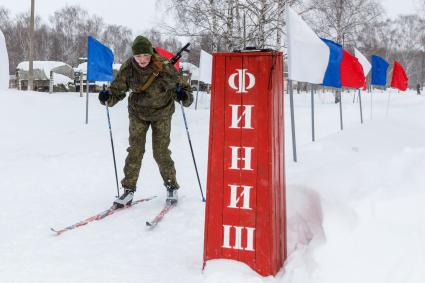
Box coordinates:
[0,5,178,74]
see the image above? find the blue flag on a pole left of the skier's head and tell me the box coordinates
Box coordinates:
[87,36,114,82]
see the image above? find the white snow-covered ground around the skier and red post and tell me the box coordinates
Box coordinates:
[0,90,425,283]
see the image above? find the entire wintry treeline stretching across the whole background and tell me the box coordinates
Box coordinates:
[0,0,425,87]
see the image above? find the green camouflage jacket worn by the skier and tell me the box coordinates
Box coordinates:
[108,54,193,121]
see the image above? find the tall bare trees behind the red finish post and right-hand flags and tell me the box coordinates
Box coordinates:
[163,0,425,87]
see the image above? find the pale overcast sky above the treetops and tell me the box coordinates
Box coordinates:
[0,0,419,34]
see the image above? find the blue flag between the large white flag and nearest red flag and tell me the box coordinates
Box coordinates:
[320,38,343,88]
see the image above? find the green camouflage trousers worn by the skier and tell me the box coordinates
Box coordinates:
[121,114,179,190]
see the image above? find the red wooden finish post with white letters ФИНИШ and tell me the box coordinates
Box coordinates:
[204,52,286,276]
